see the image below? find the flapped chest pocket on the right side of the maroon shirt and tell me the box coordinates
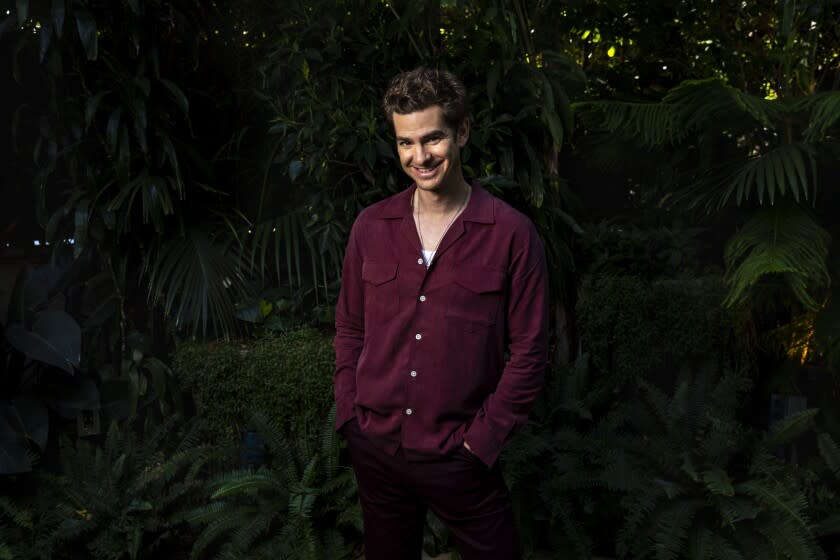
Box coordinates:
[446,265,505,331]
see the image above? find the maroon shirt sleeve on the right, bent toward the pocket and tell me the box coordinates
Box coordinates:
[464,222,548,466]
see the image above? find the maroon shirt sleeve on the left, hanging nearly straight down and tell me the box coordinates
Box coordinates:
[333,219,365,430]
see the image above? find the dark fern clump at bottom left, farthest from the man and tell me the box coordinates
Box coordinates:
[42,416,220,560]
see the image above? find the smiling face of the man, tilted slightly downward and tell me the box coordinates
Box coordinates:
[393,105,469,195]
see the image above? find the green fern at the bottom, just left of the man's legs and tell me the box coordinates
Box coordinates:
[184,408,361,560]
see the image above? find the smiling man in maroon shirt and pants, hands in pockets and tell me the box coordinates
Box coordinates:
[335,68,547,560]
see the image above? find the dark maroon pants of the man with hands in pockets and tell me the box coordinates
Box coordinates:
[341,420,521,560]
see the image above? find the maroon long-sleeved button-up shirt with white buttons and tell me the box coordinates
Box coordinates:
[335,183,548,465]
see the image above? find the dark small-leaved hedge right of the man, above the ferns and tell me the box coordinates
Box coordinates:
[576,275,744,379]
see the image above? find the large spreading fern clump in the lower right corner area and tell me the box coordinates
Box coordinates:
[604,367,825,560]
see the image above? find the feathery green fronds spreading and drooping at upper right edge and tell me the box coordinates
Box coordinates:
[580,74,840,309]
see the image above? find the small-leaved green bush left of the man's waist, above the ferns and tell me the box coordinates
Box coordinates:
[173,328,335,438]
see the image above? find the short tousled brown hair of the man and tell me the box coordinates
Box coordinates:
[382,66,469,130]
